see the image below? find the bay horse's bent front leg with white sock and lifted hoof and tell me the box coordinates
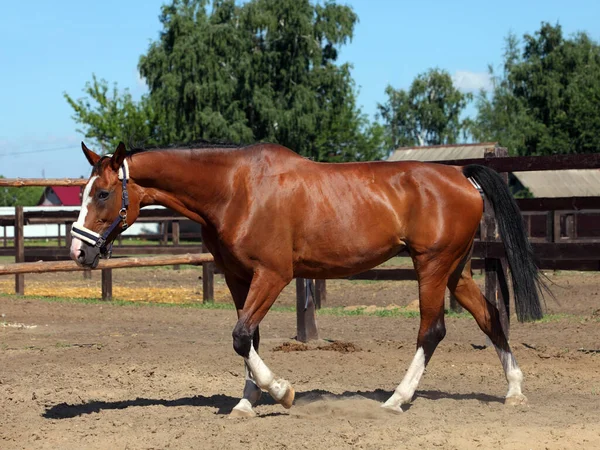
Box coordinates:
[232,270,295,414]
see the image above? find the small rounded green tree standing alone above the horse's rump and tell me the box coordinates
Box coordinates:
[377,69,472,148]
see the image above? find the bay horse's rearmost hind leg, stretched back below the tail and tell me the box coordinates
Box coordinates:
[448,262,527,405]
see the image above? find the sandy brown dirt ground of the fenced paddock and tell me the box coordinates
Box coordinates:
[0,269,600,449]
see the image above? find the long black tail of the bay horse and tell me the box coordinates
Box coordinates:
[463,165,548,322]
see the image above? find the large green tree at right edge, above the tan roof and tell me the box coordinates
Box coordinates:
[472,23,600,155]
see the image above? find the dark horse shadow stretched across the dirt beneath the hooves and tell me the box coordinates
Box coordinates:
[42,389,504,419]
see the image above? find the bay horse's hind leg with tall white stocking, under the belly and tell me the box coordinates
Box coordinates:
[382,260,448,412]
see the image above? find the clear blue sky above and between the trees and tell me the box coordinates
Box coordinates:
[0,0,600,177]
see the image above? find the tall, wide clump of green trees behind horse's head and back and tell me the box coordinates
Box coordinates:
[66,0,382,161]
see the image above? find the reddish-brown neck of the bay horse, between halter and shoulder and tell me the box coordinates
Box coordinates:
[130,149,235,226]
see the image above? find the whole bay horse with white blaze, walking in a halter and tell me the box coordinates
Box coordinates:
[70,143,543,416]
